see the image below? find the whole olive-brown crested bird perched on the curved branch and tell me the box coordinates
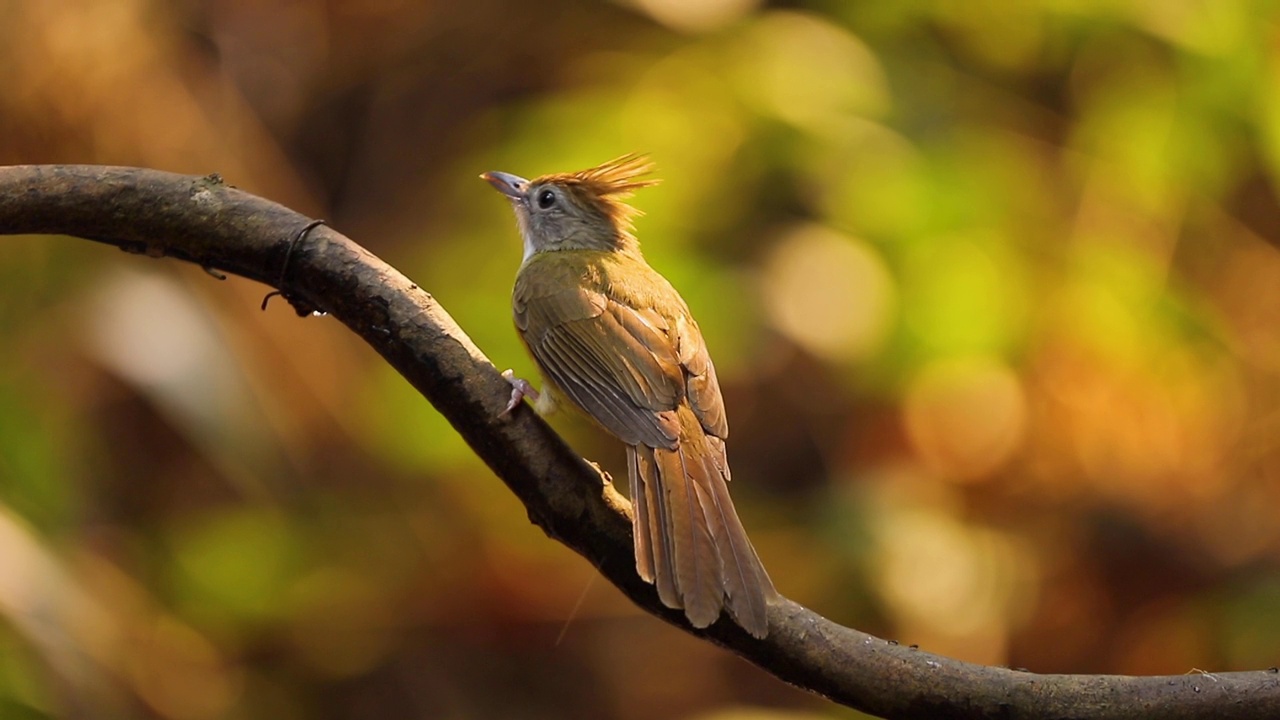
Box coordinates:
[480,155,777,638]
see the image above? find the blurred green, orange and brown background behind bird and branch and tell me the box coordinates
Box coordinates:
[0,0,1280,720]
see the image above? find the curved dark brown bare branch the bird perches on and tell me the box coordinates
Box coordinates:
[0,165,1280,720]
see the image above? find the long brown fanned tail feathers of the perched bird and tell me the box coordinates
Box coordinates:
[627,407,777,638]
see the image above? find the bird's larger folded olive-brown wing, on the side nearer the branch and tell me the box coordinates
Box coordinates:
[513,283,691,450]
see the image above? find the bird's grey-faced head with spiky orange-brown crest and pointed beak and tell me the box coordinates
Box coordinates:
[480,154,658,260]
